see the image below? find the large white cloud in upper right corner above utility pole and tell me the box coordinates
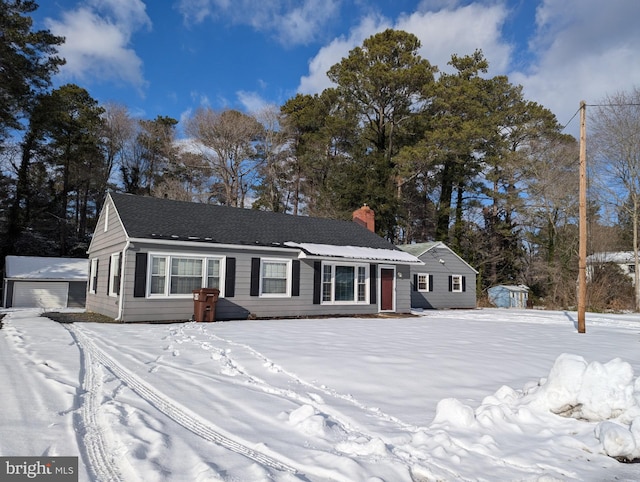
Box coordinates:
[509,0,640,136]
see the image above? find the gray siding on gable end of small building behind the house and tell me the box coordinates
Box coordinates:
[410,246,476,309]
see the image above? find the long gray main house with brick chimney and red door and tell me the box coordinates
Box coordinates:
[87,193,421,322]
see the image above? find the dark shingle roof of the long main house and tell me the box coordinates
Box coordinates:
[110,193,397,250]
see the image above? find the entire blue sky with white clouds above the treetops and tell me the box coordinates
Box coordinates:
[34,0,640,135]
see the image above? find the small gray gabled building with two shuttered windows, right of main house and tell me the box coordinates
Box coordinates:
[398,242,478,309]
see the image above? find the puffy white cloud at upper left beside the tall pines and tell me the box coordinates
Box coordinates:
[46,0,151,92]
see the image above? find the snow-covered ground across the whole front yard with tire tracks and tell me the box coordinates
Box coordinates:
[0,309,640,482]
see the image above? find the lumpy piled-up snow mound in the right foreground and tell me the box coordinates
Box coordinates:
[432,353,640,462]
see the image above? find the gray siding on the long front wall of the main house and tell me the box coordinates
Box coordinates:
[113,243,410,322]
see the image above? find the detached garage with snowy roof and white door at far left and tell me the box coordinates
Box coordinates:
[3,256,89,309]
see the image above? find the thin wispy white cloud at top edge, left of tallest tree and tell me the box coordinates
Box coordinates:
[178,0,341,46]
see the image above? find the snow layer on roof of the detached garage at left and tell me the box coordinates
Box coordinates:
[5,256,89,281]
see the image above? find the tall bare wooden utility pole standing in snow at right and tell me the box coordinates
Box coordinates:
[578,100,587,333]
